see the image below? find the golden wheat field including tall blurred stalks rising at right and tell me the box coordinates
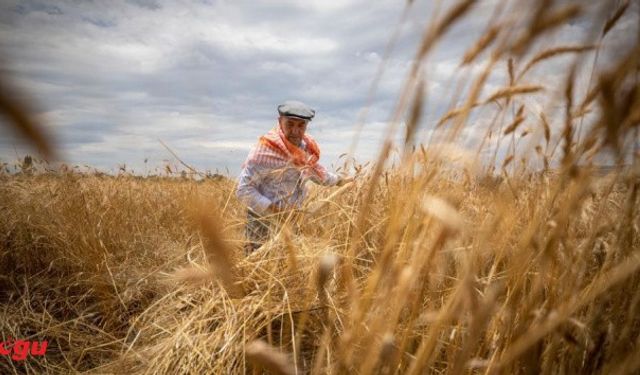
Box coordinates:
[0,1,640,374]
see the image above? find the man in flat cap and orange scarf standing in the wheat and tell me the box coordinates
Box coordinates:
[236,101,351,254]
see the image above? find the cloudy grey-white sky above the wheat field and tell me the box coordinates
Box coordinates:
[0,0,637,176]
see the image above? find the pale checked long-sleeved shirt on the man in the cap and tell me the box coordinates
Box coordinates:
[236,137,339,214]
